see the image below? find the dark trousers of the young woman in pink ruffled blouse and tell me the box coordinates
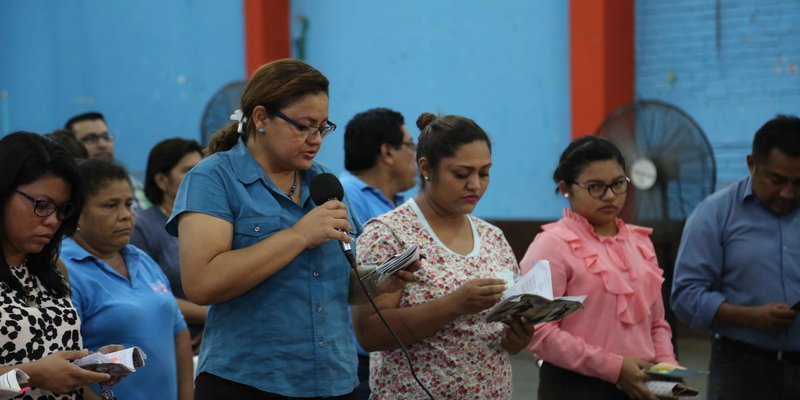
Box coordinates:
[538,362,629,400]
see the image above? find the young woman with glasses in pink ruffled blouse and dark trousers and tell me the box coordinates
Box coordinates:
[521,136,677,400]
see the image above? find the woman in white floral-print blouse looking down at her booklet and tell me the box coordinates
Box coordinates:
[353,113,533,399]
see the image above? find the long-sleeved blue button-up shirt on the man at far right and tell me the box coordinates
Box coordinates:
[671,177,800,351]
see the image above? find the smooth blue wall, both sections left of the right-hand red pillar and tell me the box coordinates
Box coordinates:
[0,0,570,219]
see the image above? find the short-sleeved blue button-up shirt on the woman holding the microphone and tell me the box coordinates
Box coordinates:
[167,141,361,397]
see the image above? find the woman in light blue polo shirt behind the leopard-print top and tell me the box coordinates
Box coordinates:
[61,158,193,400]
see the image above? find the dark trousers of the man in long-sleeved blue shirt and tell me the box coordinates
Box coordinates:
[708,338,800,400]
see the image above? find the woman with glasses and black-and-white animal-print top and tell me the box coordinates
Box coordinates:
[0,132,110,400]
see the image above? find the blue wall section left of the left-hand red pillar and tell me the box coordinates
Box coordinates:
[0,0,245,175]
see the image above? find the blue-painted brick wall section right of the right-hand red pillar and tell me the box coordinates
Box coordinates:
[636,0,800,187]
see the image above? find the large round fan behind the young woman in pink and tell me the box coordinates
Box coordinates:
[596,100,717,242]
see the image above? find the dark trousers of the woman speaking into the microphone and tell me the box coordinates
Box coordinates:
[194,372,356,400]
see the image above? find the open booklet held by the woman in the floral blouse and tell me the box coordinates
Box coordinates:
[484,260,586,324]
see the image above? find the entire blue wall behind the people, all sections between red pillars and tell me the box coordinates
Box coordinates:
[0,0,800,220]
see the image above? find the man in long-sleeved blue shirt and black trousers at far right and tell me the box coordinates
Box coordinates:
[671,116,800,400]
